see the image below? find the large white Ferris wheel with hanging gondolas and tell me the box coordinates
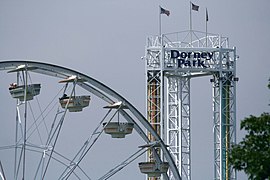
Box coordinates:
[0,60,181,180]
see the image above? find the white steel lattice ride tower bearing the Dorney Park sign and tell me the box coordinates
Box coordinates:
[145,31,238,180]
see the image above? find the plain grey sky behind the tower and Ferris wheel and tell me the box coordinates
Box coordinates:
[0,0,270,180]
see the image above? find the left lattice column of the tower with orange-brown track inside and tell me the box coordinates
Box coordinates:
[145,36,164,180]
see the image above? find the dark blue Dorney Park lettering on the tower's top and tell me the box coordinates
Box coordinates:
[170,50,214,68]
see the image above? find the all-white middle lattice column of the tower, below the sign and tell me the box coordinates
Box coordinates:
[167,76,191,180]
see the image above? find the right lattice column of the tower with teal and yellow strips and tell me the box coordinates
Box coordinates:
[212,49,237,180]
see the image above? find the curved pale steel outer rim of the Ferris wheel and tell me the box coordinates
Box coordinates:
[0,60,181,180]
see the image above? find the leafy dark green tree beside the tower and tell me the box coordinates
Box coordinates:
[229,79,270,180]
